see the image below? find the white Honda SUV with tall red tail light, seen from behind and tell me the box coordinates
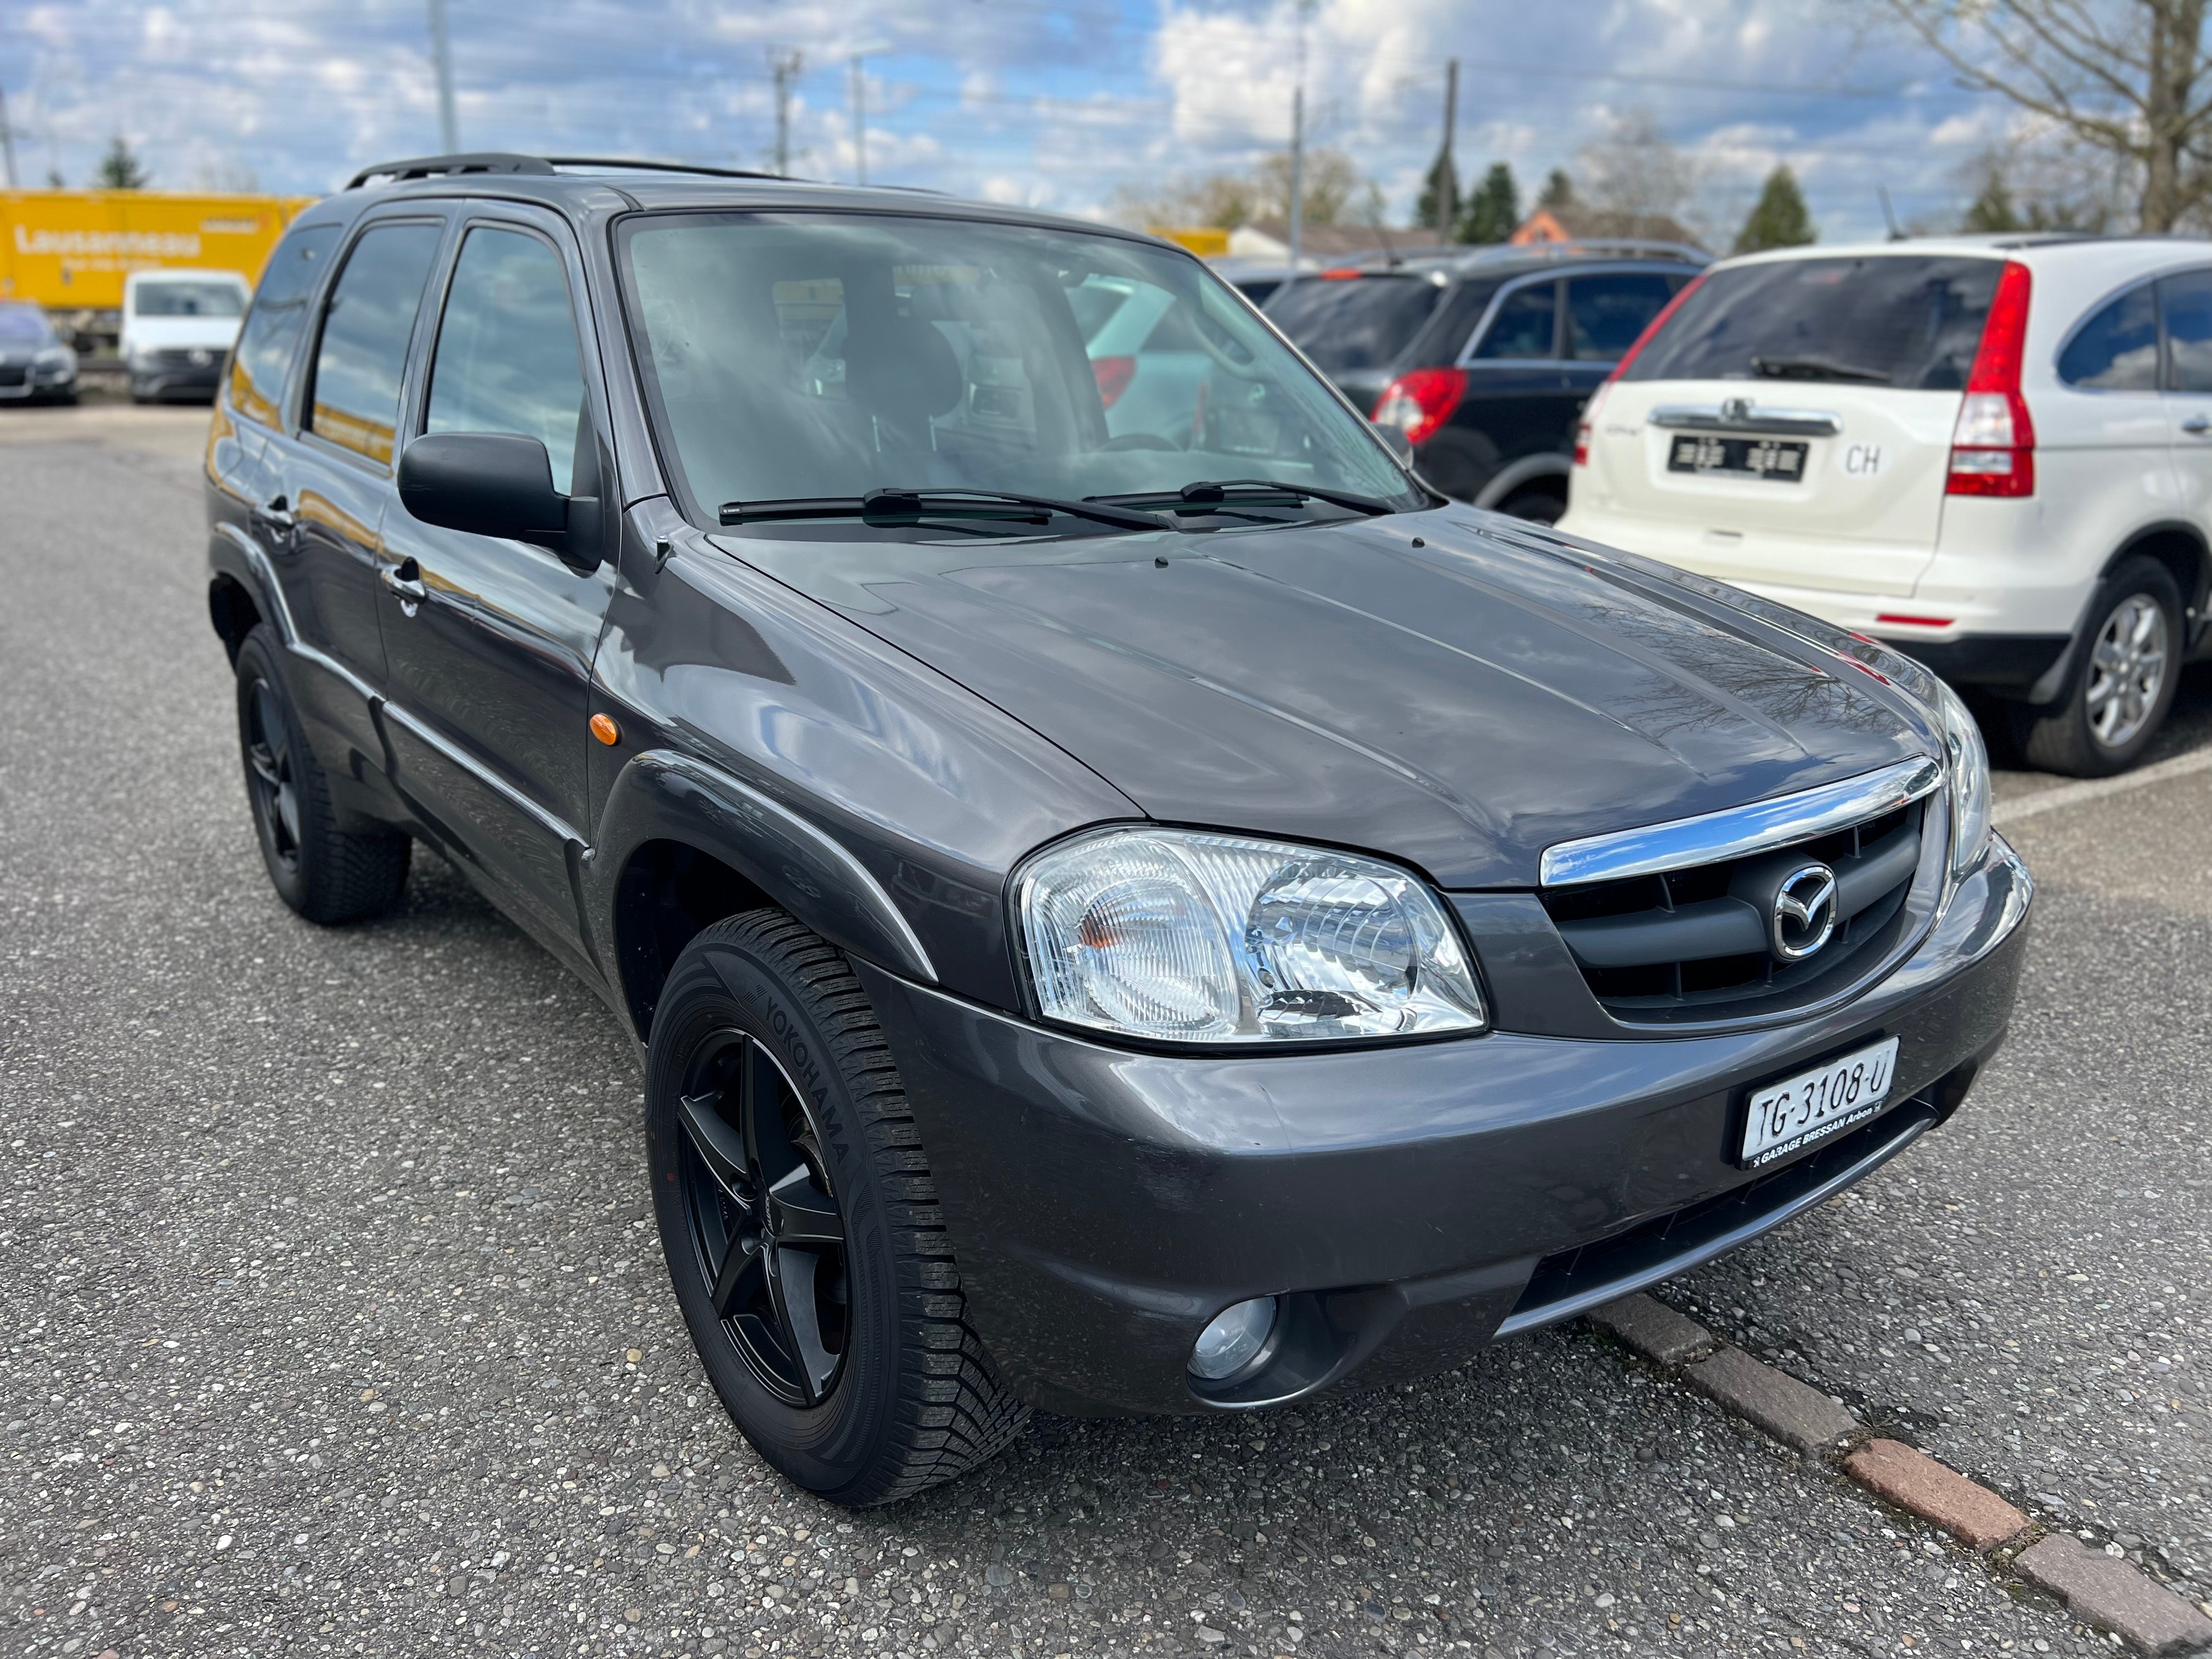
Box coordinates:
[1560,236,2212,776]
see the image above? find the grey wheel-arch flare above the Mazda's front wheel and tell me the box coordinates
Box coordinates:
[586,750,938,1000]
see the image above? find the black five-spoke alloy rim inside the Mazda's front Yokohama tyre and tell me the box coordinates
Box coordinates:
[677,1026,851,1407]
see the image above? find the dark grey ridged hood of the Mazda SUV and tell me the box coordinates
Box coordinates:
[716,506,1938,889]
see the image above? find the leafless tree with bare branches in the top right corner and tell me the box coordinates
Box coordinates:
[1884,0,2212,230]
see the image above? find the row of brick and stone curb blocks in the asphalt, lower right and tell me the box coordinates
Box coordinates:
[1588,1294,2212,1659]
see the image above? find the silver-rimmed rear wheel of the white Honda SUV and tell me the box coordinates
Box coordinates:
[2017,560,2181,778]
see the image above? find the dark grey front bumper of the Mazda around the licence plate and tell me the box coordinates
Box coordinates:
[858,840,2033,1415]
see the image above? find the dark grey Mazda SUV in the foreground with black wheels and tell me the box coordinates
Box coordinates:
[206,155,2033,1504]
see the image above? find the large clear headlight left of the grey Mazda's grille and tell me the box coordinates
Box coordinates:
[1015,830,1484,1044]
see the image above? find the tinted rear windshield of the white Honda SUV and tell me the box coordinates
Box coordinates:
[1621,255,2004,392]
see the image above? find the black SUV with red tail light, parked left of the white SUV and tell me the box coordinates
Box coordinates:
[1267,244,1706,524]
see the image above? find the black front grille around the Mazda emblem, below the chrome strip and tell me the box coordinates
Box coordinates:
[1544,799,1929,1022]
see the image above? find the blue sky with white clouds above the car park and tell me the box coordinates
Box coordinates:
[0,0,2011,241]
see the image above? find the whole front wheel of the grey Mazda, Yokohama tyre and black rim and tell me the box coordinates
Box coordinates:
[646,909,1029,1506]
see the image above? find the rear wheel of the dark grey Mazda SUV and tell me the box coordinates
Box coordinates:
[239,624,414,924]
